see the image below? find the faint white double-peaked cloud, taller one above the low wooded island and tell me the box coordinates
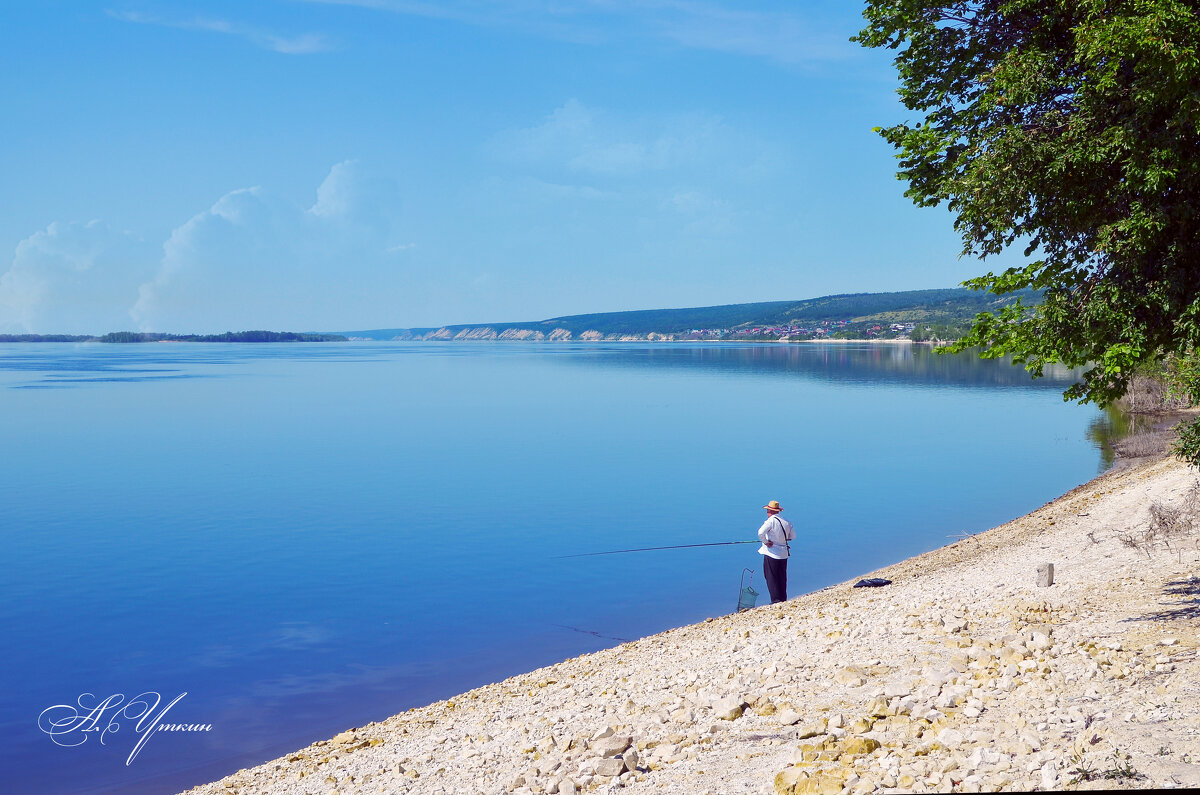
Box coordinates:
[132,161,406,331]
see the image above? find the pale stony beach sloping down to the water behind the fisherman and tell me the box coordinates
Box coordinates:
[190,451,1200,795]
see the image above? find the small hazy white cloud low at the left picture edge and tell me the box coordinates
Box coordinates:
[0,221,155,334]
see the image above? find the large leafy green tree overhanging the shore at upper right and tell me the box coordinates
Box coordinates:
[854,0,1200,464]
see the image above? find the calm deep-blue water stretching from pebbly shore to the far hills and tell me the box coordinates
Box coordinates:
[0,343,1103,793]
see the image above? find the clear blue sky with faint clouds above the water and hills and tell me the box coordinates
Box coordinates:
[0,0,1012,333]
